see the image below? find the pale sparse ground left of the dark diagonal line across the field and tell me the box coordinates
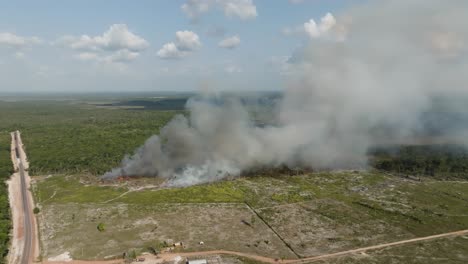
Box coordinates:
[40,203,294,259]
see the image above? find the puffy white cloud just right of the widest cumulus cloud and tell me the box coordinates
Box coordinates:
[156,30,202,59]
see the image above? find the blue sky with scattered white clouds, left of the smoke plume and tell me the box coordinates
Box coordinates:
[0,0,361,92]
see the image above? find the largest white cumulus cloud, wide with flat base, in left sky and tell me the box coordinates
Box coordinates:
[57,24,149,63]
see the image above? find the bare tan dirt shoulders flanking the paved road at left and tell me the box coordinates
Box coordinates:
[7,132,40,263]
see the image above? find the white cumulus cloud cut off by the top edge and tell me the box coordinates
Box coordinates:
[181,0,257,20]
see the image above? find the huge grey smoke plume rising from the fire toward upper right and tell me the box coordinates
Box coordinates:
[104,0,468,186]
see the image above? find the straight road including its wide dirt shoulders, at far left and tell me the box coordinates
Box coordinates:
[8,131,39,264]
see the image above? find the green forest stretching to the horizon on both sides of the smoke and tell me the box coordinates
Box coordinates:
[0,99,468,179]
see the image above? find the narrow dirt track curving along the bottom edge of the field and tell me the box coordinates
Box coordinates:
[44,229,468,264]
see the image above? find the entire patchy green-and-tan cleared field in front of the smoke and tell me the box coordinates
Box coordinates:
[34,171,468,259]
